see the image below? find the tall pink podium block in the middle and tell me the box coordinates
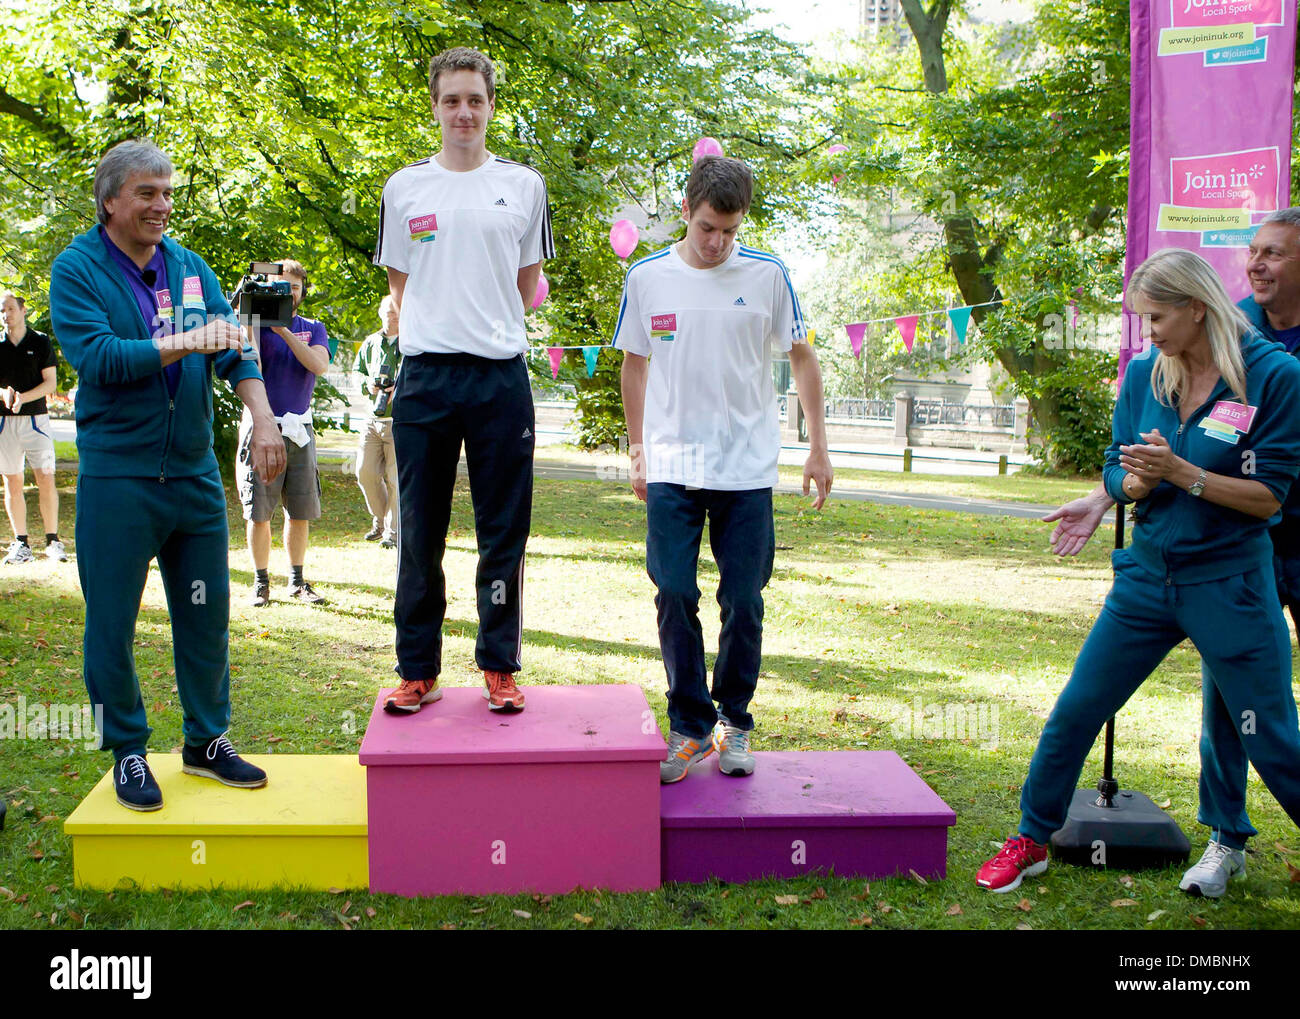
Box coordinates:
[360,686,667,896]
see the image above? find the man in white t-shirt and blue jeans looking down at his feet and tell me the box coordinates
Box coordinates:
[614,156,833,782]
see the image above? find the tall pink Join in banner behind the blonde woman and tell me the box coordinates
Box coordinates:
[1119,0,1296,381]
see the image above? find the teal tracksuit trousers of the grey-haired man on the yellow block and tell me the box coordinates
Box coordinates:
[77,469,230,760]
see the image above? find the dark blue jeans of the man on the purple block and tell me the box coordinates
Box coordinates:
[646,482,776,740]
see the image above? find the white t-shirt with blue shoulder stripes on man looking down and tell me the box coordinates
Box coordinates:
[614,244,807,491]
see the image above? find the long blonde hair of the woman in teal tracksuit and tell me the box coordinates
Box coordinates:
[1128,248,1251,407]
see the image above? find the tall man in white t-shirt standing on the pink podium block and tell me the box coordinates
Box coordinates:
[374,47,555,714]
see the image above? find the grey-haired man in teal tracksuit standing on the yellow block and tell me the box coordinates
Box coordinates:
[49,142,285,810]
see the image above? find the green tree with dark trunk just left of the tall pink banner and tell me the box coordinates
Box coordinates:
[840,0,1128,471]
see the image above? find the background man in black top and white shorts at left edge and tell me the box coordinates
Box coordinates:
[0,291,68,565]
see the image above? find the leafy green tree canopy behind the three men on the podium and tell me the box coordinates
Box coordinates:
[0,0,824,457]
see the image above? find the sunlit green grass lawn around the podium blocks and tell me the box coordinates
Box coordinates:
[0,473,1300,929]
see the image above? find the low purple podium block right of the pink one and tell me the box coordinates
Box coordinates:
[660,750,957,881]
